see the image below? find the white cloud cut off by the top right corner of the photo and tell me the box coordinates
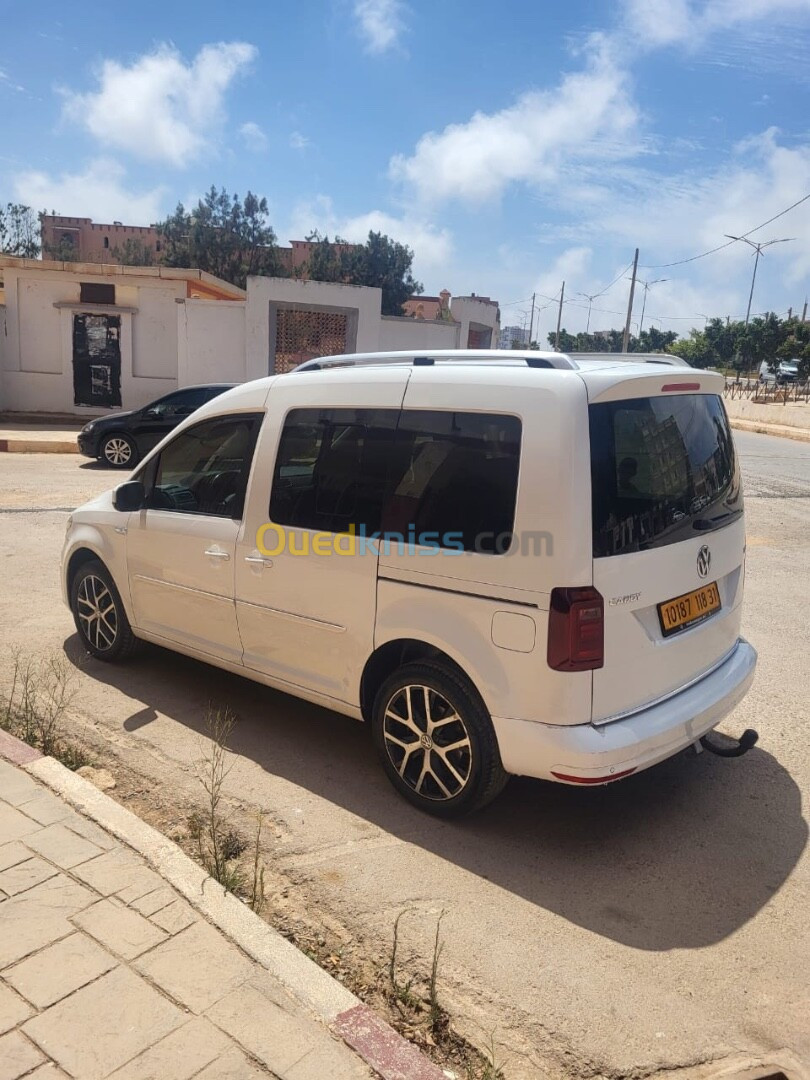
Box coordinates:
[624,0,810,48]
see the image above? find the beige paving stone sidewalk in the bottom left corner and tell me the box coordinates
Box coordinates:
[0,760,374,1080]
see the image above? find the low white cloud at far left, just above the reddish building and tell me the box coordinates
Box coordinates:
[14,158,166,225]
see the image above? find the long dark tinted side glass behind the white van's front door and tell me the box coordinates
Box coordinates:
[270,408,521,554]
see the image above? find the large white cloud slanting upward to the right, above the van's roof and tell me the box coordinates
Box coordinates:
[390,35,638,203]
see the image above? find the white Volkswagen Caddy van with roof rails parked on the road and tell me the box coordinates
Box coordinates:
[63,351,756,816]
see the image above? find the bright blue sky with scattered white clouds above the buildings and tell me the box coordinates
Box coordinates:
[0,0,810,336]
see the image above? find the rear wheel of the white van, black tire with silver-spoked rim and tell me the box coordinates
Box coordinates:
[372,662,509,818]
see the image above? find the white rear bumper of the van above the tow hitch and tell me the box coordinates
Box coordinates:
[492,637,757,784]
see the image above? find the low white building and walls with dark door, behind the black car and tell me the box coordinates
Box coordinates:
[0,256,499,416]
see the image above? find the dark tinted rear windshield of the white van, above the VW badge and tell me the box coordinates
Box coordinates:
[589,394,742,558]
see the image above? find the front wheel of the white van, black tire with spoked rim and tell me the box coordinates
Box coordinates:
[70,558,140,663]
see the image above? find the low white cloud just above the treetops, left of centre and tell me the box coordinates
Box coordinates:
[287,195,453,278]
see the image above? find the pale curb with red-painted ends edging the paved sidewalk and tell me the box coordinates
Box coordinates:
[0,731,450,1080]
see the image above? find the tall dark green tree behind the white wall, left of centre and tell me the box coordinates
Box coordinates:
[158,185,281,288]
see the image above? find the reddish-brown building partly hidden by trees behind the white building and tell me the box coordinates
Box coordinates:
[41,214,357,274]
